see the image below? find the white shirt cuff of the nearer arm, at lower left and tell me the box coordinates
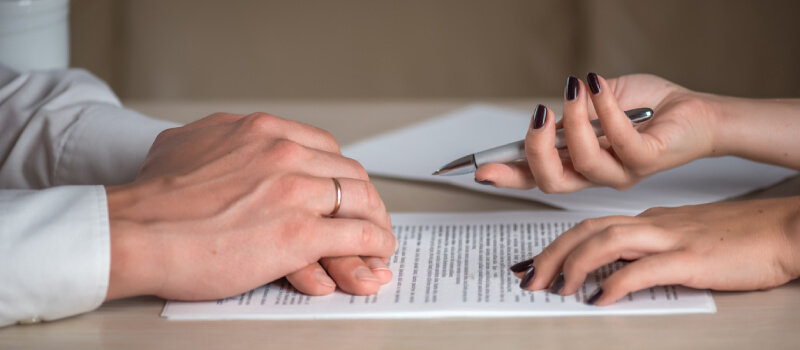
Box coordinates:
[0,186,111,327]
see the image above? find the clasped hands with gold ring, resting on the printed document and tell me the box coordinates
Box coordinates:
[106,113,397,300]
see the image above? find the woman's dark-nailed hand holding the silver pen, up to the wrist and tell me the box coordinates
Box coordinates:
[475,73,717,193]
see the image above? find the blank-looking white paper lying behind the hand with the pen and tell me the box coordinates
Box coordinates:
[342,105,797,213]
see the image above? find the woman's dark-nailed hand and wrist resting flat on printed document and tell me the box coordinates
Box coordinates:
[515,197,800,305]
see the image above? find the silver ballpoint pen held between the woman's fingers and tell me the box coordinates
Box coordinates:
[432,108,653,176]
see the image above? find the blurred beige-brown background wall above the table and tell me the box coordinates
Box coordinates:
[71,0,800,99]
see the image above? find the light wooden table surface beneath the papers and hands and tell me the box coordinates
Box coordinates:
[0,99,800,350]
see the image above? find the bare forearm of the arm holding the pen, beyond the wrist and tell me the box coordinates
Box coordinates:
[701,94,800,170]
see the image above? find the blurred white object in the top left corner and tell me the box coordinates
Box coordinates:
[0,0,69,72]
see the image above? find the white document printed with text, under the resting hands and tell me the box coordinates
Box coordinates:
[162,211,716,320]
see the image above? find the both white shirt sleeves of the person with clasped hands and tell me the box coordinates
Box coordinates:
[0,65,177,326]
